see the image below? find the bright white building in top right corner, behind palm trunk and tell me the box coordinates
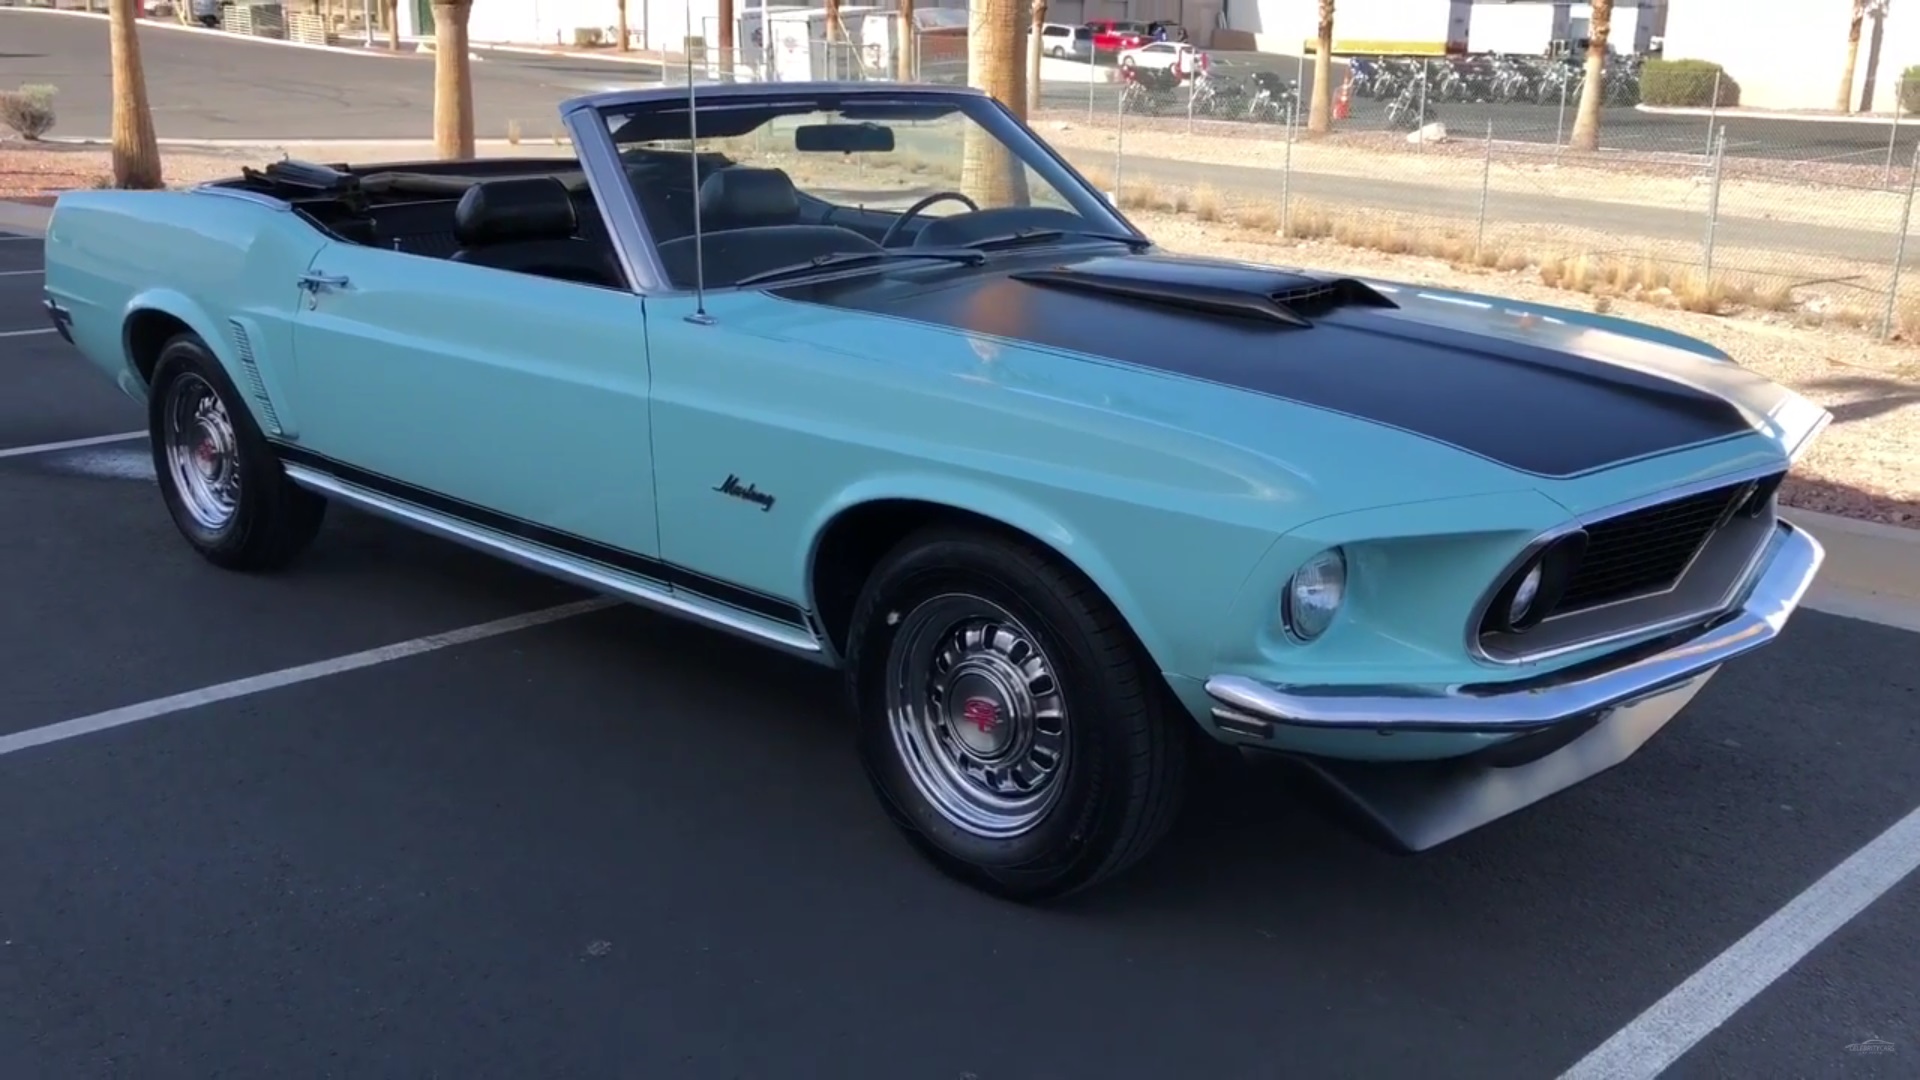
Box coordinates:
[1663,0,1920,111]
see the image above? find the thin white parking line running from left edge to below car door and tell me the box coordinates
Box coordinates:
[0,598,618,757]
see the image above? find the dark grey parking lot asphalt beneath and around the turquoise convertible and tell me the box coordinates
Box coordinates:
[0,222,1920,1080]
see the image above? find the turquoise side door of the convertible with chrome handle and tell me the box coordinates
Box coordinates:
[294,242,659,555]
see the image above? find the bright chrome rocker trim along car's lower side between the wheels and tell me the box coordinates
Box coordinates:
[284,463,829,663]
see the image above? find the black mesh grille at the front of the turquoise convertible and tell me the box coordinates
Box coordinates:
[1553,474,1764,615]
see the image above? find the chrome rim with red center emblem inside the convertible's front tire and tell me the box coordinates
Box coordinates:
[887,596,1068,840]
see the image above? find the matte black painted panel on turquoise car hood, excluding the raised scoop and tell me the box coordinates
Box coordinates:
[772,256,1753,479]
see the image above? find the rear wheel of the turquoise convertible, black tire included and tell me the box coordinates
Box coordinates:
[148,334,326,571]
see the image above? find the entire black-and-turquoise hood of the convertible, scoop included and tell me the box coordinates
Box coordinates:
[752,252,1828,518]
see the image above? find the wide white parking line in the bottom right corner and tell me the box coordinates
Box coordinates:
[1561,809,1920,1080]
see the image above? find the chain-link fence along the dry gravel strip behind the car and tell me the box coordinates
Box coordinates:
[1033,54,1920,332]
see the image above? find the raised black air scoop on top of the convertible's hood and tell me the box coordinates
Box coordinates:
[1008,256,1398,327]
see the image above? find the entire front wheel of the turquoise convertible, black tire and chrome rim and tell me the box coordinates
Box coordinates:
[847,528,1190,901]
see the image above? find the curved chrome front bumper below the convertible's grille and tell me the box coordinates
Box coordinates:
[1206,521,1826,740]
